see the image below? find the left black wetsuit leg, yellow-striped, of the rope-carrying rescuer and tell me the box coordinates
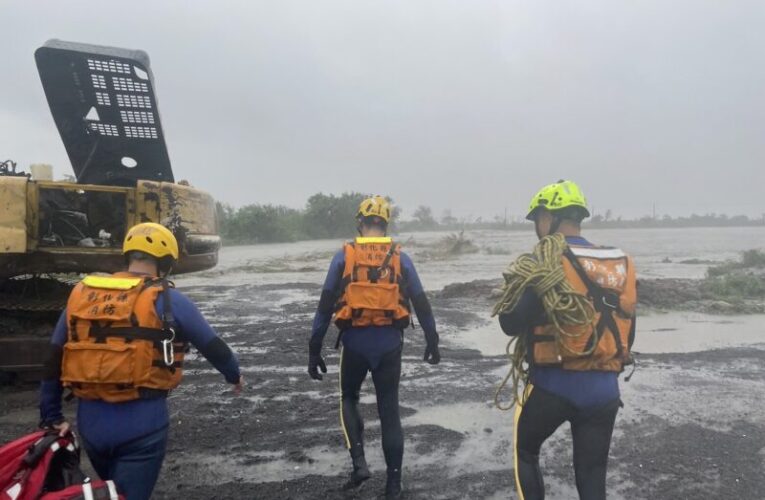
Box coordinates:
[514,387,574,500]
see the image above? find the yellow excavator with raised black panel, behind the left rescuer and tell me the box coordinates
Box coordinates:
[0,40,220,381]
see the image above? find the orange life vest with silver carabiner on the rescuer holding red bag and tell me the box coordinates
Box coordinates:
[61,273,185,403]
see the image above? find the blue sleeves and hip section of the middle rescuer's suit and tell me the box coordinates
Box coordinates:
[311,250,436,369]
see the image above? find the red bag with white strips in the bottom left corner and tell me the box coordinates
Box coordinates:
[0,431,124,500]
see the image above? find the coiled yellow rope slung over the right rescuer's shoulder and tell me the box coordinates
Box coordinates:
[491,233,598,410]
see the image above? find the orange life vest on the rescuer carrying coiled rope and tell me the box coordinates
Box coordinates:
[530,245,637,372]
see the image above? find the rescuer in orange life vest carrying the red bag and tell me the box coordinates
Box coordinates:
[40,223,244,500]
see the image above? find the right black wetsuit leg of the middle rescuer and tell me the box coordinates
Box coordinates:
[372,347,404,474]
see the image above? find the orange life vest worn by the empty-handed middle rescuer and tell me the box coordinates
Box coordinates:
[335,237,410,331]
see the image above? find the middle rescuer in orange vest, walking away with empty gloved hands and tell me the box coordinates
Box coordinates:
[308,196,441,498]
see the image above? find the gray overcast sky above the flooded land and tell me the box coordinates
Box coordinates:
[0,0,765,216]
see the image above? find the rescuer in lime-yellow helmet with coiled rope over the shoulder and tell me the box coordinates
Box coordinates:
[499,181,637,500]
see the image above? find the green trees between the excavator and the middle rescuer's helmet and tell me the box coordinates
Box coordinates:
[217,192,398,244]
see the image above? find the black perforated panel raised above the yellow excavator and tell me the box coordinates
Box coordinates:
[35,40,173,186]
